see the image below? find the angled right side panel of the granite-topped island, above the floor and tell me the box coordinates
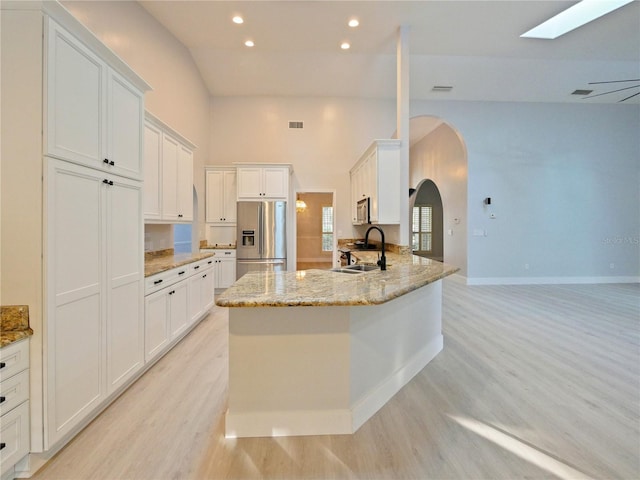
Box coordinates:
[350,280,443,431]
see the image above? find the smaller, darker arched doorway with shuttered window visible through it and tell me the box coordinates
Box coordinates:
[409,179,444,262]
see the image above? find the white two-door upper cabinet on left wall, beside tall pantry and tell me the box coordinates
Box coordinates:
[144,112,195,223]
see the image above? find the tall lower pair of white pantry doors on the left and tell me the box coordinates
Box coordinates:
[45,159,143,445]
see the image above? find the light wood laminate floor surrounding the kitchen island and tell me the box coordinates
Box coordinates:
[34,277,640,480]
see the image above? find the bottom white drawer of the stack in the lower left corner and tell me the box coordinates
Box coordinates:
[0,401,29,474]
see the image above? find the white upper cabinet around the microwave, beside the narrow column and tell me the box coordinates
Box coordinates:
[350,140,405,225]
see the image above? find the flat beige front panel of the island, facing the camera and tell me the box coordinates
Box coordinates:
[225,307,352,437]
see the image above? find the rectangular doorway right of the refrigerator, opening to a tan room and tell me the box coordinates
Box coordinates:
[296,191,336,270]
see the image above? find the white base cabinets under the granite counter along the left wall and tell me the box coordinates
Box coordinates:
[145,259,215,362]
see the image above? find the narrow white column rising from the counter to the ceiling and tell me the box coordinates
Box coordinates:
[396,25,410,245]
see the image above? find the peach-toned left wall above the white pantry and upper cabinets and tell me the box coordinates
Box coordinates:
[62,1,210,239]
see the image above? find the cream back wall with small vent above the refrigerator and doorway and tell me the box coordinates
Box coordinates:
[211,97,395,238]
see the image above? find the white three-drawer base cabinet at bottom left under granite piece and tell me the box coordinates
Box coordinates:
[0,339,29,478]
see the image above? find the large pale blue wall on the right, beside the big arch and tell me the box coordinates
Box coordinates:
[412,102,640,283]
